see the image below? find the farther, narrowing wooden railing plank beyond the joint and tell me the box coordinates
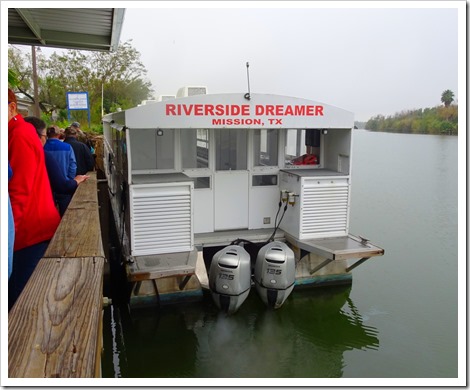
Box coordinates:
[44,172,104,258]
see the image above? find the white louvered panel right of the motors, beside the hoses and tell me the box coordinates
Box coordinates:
[300,179,349,238]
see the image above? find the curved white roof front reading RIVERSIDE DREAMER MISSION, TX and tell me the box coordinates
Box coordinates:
[103,93,354,131]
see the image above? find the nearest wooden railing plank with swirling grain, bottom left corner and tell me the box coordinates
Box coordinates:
[8,257,104,378]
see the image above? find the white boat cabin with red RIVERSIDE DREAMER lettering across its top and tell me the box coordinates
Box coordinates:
[103,87,383,308]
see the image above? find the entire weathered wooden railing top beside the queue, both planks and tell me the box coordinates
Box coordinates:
[8,172,105,378]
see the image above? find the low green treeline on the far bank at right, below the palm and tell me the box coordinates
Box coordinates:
[365,105,458,135]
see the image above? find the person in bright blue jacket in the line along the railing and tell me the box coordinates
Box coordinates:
[44,125,77,179]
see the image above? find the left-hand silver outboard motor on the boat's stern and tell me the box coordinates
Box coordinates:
[209,245,251,314]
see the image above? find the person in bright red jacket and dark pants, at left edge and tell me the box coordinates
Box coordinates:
[8,89,60,309]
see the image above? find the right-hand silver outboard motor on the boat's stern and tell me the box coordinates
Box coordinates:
[255,241,295,309]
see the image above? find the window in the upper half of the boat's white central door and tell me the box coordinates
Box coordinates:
[215,129,248,171]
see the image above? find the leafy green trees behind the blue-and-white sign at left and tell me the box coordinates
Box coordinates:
[8,41,153,126]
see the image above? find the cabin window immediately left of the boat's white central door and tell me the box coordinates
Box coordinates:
[181,129,209,169]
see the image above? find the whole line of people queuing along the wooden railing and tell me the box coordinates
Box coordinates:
[8,89,95,309]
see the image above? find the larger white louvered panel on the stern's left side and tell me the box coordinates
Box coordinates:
[131,182,193,256]
